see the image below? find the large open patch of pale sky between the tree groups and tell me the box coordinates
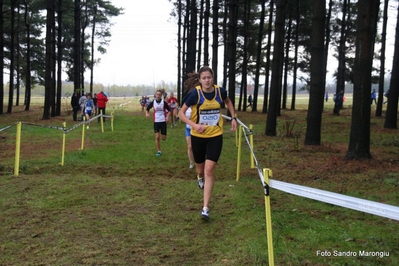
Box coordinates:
[93,0,177,86]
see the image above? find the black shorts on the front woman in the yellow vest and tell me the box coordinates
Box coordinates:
[191,135,223,163]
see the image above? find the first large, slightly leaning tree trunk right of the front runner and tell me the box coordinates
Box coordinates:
[265,0,286,136]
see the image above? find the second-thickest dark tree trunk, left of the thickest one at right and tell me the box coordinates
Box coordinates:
[305,0,326,145]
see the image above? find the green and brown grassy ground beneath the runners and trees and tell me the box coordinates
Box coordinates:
[0,97,399,265]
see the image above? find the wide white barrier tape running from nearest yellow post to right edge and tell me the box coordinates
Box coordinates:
[269,179,399,221]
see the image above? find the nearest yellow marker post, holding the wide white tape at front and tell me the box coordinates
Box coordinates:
[263,168,274,266]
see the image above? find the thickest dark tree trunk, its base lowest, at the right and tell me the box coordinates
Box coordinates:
[346,0,380,159]
